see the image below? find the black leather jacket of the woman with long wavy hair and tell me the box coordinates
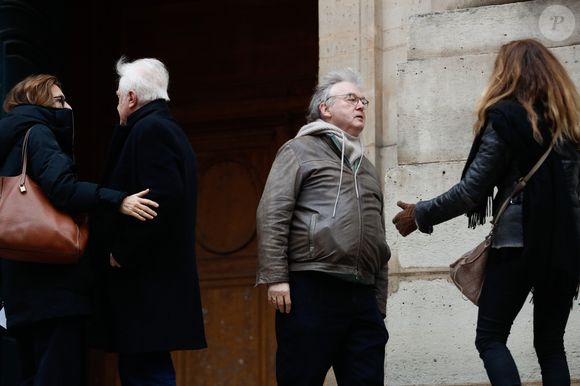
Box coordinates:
[415,124,580,248]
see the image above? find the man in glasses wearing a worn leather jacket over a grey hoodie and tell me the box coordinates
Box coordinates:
[256,69,390,386]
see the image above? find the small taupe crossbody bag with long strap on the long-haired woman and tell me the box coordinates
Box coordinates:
[449,142,554,305]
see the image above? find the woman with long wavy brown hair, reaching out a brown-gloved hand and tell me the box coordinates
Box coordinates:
[393,39,580,386]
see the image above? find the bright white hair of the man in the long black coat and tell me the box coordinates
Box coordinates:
[117,56,169,105]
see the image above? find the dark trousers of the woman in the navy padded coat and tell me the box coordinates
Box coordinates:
[10,317,84,386]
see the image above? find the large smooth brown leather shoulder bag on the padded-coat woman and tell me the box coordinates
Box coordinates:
[0,129,89,264]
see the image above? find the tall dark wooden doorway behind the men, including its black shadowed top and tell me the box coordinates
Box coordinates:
[78,0,318,386]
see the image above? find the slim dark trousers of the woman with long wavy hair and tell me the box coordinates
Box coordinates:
[475,248,572,386]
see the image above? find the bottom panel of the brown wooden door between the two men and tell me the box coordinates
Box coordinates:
[174,279,275,386]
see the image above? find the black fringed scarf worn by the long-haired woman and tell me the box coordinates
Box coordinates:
[462,100,580,295]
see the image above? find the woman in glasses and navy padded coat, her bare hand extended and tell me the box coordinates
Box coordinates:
[0,75,157,386]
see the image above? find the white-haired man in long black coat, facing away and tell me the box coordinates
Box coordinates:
[99,58,206,386]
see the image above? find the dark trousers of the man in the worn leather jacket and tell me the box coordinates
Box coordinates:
[276,271,388,386]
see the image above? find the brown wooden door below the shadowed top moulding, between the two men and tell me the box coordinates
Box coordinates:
[175,121,284,386]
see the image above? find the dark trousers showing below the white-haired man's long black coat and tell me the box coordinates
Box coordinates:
[119,351,175,386]
